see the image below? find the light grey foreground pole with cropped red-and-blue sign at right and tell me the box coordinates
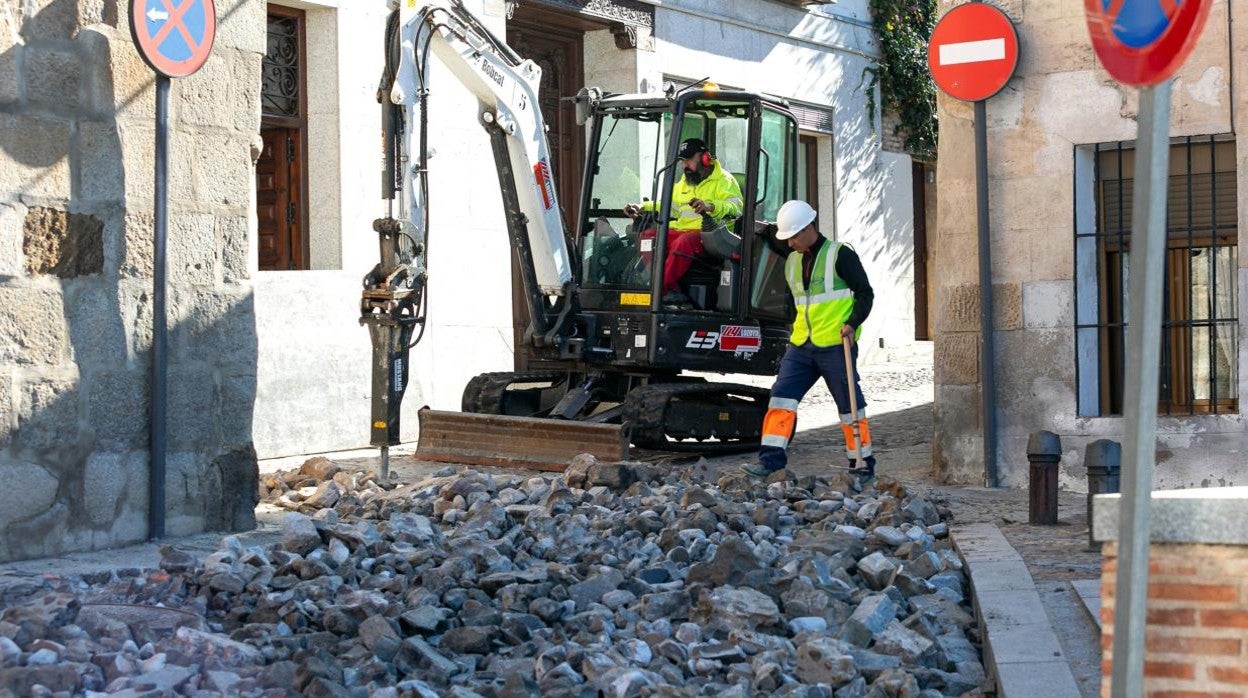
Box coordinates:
[1085,0,1211,698]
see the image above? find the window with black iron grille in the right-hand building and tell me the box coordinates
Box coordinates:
[1075,136,1239,416]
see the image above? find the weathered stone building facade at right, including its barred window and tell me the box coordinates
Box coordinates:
[932,0,1248,489]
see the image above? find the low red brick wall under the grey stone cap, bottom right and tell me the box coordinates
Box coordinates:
[1101,543,1248,698]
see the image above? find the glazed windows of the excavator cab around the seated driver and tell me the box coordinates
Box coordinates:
[579,95,796,318]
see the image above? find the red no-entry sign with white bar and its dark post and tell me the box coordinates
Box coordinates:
[927,2,1018,487]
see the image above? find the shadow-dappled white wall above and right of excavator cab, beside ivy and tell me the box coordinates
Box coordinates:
[641,0,915,362]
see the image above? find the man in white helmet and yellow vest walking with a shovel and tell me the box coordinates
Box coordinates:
[741,201,875,484]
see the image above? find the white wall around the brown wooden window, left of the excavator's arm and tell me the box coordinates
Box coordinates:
[251,0,428,458]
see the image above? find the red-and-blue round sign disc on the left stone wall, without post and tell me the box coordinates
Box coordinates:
[130,0,217,77]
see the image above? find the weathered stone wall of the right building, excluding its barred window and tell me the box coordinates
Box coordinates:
[929,0,1248,491]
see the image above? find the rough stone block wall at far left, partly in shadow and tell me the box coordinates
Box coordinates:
[0,0,265,561]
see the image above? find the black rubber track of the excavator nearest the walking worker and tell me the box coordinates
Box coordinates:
[624,382,770,456]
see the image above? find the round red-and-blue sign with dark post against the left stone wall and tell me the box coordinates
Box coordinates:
[130,0,217,541]
